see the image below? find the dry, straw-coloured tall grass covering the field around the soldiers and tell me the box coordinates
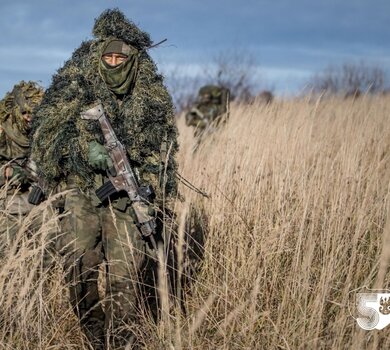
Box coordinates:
[0,97,390,350]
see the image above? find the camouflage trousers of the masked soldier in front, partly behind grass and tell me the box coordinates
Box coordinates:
[57,190,154,349]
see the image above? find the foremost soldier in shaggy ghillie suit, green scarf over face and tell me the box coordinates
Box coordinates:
[32,9,178,349]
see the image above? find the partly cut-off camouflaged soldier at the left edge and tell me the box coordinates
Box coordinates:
[0,81,43,243]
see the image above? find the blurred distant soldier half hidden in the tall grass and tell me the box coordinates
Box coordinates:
[186,85,230,136]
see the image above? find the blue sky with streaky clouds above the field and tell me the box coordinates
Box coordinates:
[0,0,390,96]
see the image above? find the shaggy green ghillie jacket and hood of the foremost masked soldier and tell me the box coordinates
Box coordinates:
[32,9,178,200]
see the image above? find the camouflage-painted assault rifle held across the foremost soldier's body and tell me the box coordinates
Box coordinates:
[81,104,157,249]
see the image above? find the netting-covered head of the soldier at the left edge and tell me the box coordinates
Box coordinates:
[5,81,44,132]
